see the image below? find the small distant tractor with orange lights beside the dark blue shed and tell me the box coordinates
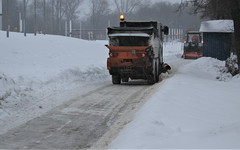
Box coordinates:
[182,31,203,59]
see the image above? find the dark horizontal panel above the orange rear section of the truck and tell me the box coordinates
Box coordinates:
[109,36,149,46]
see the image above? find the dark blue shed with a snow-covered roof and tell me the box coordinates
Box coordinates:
[199,20,234,60]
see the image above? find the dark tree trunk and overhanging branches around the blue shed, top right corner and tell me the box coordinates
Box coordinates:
[180,0,240,72]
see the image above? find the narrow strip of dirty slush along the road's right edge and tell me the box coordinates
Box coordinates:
[91,58,193,149]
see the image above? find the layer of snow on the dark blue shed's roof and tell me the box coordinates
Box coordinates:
[199,20,234,32]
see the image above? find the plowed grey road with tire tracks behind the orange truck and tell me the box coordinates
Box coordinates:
[0,78,172,149]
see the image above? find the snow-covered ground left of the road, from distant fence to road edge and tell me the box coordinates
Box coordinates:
[0,31,110,133]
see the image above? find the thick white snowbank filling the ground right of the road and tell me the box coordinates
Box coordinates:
[109,58,240,149]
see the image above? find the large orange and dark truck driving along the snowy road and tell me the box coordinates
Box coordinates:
[106,18,171,84]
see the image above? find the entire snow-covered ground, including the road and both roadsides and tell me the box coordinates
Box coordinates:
[0,31,240,149]
